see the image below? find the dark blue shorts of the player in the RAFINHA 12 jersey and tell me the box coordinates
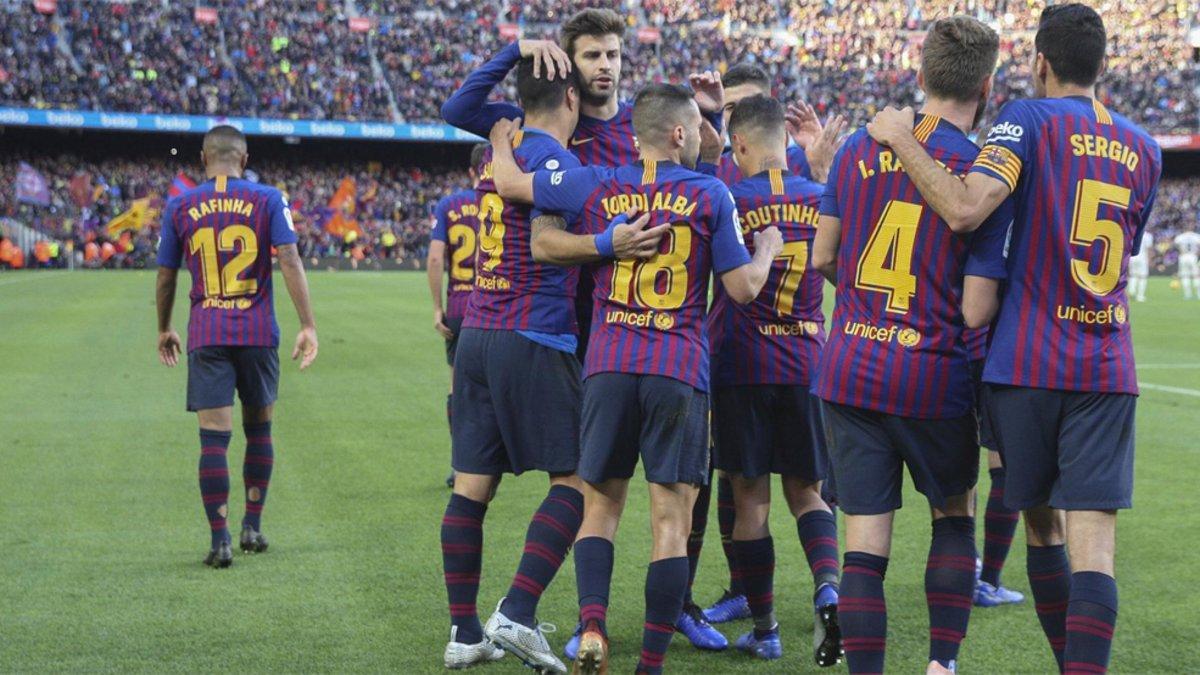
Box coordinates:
[187,345,280,412]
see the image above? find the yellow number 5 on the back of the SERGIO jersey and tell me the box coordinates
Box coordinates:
[1070,178,1130,295]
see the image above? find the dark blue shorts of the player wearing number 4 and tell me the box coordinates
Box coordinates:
[824,401,979,515]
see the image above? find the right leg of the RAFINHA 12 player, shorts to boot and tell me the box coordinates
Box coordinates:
[230,347,280,552]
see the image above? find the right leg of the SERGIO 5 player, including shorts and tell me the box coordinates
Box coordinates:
[1050,393,1138,673]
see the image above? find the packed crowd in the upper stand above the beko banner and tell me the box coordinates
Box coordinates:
[0,0,1200,132]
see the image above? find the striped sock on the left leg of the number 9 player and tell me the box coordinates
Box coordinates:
[442,487,487,645]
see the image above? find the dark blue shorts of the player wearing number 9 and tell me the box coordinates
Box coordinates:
[450,328,581,476]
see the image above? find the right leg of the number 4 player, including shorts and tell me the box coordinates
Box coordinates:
[886,410,979,673]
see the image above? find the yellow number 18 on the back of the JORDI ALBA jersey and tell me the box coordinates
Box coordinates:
[608,225,691,310]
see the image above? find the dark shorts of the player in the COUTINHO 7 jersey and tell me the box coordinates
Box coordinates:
[713,384,828,483]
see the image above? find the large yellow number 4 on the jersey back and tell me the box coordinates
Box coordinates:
[854,199,922,313]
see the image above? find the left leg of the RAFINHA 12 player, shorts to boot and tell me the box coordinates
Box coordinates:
[187,346,238,567]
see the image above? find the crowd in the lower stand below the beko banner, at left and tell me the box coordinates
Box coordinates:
[0,154,467,267]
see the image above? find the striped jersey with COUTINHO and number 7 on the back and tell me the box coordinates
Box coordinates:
[708,169,824,387]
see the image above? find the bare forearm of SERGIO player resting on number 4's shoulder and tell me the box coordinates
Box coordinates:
[866,107,1015,233]
